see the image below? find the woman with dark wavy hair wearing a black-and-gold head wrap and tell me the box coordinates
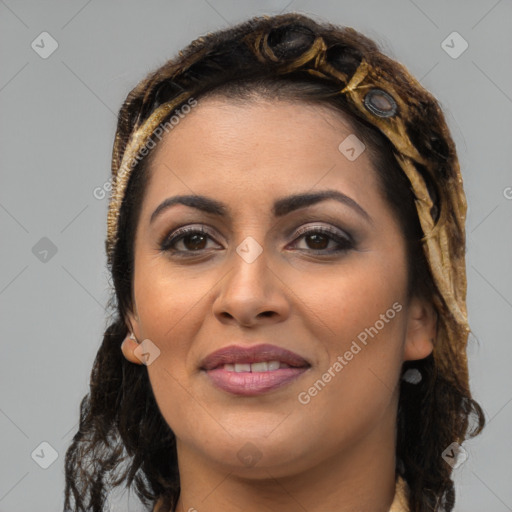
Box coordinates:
[65,14,484,512]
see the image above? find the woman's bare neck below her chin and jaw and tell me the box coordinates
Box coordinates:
[175,408,395,512]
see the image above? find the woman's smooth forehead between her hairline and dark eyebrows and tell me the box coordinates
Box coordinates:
[130,98,394,235]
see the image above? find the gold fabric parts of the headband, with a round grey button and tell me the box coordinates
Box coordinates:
[106,22,469,387]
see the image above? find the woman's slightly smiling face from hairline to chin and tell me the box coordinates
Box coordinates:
[129,98,435,477]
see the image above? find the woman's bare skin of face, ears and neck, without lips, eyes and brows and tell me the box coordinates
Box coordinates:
[122,97,436,512]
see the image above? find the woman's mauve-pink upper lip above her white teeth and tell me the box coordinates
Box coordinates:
[200,343,311,370]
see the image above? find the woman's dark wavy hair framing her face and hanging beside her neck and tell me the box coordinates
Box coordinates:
[64,14,485,512]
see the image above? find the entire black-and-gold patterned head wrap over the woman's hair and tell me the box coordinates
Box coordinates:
[106,13,469,389]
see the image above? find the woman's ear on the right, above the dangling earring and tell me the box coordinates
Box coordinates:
[404,297,437,361]
